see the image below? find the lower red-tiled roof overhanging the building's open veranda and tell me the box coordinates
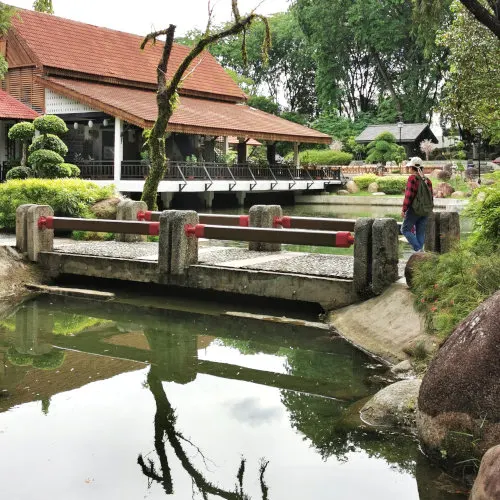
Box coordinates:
[40,78,331,144]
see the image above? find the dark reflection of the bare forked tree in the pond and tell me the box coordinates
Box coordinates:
[137,366,268,500]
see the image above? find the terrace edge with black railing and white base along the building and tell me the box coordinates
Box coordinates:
[79,161,343,197]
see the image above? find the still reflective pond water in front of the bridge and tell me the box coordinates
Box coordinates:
[0,297,465,500]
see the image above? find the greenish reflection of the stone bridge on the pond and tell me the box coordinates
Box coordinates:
[0,298,382,410]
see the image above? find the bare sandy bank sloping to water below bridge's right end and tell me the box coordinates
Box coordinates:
[328,281,429,363]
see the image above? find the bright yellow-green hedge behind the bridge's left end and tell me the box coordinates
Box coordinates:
[0,179,115,229]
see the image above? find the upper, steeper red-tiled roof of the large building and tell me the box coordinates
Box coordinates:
[13,9,245,101]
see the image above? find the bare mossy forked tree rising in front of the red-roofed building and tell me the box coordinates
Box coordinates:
[141,0,271,210]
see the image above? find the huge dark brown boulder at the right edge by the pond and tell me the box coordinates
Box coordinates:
[417,291,500,463]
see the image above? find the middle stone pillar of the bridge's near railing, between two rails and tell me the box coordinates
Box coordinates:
[158,210,199,275]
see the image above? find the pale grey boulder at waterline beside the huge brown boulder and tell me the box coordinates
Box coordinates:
[360,379,421,428]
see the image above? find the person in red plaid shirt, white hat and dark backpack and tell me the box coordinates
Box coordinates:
[401,157,434,252]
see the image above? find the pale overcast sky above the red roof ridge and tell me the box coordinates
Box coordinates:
[5,0,289,35]
